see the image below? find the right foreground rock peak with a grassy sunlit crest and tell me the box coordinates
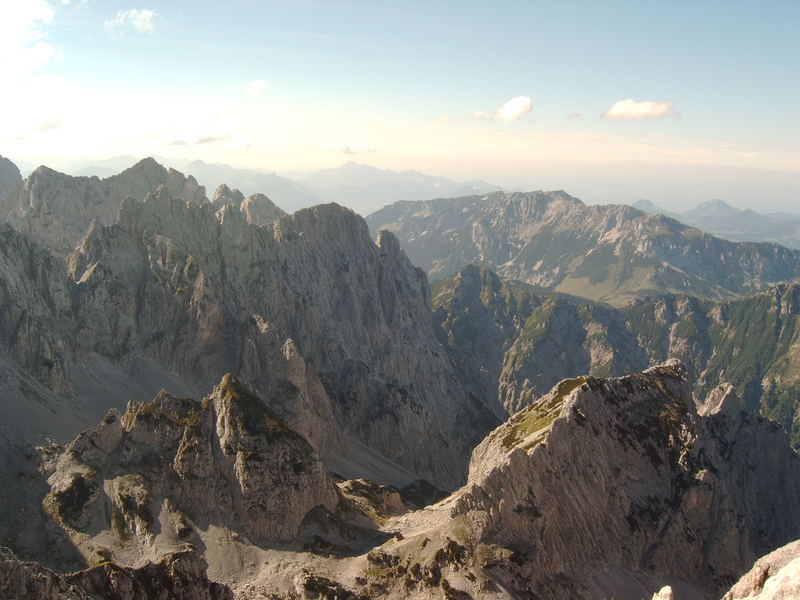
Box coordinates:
[458,363,800,593]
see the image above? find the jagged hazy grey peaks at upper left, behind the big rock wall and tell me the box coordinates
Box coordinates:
[0,158,207,255]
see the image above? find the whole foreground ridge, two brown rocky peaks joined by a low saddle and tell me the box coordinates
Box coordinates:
[0,361,800,600]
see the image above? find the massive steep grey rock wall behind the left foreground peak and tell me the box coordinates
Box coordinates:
[0,186,496,487]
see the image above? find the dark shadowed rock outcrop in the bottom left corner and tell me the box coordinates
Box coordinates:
[0,548,233,600]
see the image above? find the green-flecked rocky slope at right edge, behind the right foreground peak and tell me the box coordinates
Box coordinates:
[622,285,800,445]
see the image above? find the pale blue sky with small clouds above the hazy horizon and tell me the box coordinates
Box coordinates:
[0,0,800,210]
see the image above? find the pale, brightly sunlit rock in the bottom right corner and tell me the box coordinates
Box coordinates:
[720,541,800,600]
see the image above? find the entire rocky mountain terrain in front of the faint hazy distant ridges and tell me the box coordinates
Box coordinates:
[0,159,800,600]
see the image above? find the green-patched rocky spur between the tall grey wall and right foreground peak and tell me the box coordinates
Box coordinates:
[433,265,649,414]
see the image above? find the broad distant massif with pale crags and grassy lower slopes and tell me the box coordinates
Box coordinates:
[368,192,800,305]
